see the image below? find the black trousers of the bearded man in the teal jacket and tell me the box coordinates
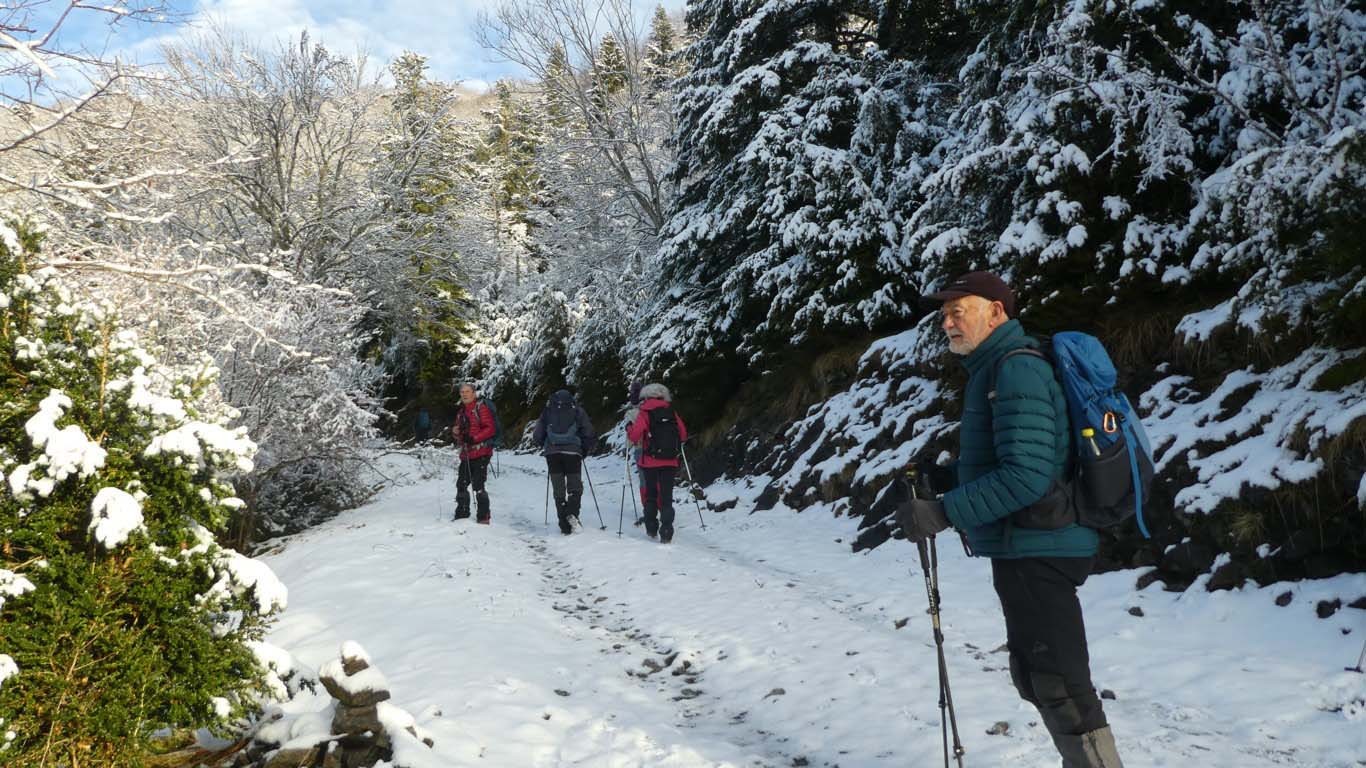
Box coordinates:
[992,558,1106,735]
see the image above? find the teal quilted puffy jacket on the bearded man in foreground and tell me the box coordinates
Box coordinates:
[944,320,1100,558]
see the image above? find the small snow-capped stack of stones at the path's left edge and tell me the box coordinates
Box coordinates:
[235,642,433,768]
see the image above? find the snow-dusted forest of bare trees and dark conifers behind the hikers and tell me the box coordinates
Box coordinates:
[0,0,1366,574]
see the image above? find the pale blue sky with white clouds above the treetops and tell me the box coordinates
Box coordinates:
[37,0,683,86]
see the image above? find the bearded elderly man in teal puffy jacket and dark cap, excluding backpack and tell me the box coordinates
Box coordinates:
[897,272,1120,768]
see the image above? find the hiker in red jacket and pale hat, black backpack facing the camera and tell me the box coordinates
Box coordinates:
[626,384,687,544]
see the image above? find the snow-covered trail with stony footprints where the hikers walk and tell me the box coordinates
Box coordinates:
[266,454,1366,768]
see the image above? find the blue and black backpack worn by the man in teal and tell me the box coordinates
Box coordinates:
[996,331,1153,538]
